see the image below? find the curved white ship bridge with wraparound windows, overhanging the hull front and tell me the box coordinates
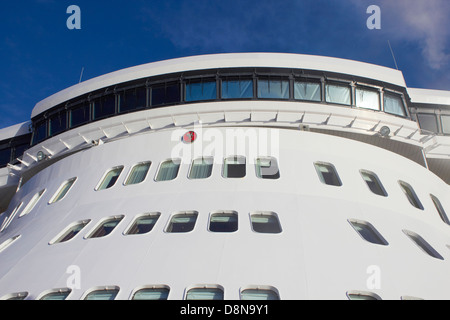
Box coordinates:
[0,53,450,211]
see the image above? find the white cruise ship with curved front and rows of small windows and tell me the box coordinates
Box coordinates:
[0,53,450,301]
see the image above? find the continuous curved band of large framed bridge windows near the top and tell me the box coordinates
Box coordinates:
[32,70,408,145]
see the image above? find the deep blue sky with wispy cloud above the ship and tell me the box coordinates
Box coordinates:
[0,0,450,128]
